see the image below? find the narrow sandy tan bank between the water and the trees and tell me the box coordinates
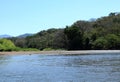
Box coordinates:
[0,50,120,55]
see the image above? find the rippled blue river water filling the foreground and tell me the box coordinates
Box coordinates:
[0,54,120,82]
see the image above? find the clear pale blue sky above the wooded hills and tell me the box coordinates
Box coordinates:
[0,0,120,36]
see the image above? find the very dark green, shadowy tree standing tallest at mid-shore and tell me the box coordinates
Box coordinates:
[64,26,83,50]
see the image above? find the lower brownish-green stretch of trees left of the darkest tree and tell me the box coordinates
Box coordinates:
[10,28,67,50]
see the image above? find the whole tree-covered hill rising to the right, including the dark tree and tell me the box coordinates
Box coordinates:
[10,13,120,50]
